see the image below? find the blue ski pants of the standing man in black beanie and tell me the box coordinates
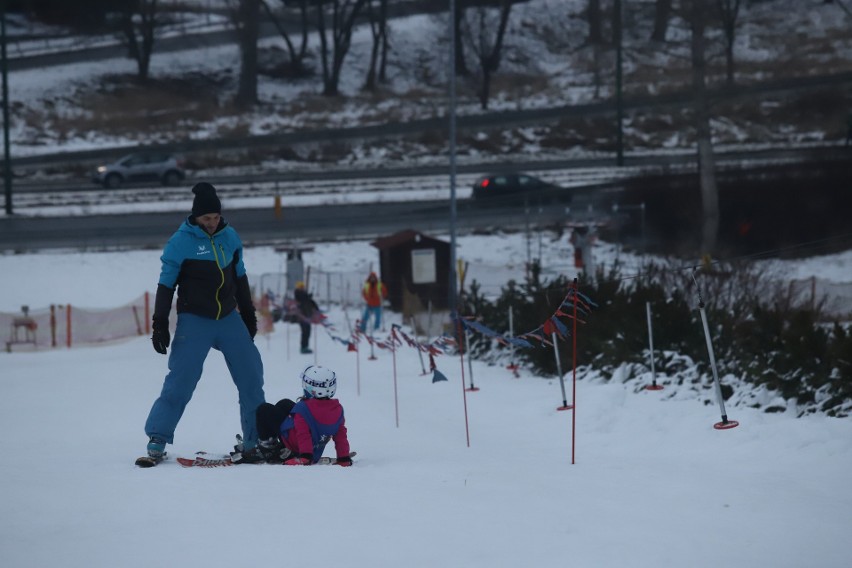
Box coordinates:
[145,310,265,448]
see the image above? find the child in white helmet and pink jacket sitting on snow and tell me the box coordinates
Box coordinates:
[231,365,352,467]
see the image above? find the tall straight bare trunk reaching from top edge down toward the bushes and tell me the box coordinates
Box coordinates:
[689,0,719,253]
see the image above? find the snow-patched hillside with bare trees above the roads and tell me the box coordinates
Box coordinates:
[10,0,852,173]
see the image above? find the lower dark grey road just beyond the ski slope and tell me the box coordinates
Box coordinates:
[0,195,586,252]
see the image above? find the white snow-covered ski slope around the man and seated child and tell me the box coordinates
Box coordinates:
[0,232,852,568]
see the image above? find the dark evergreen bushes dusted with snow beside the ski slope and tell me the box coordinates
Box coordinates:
[461,263,852,415]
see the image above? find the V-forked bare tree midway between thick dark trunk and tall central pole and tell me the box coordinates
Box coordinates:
[316,0,368,96]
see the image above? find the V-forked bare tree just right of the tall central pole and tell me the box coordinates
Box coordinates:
[462,0,514,110]
